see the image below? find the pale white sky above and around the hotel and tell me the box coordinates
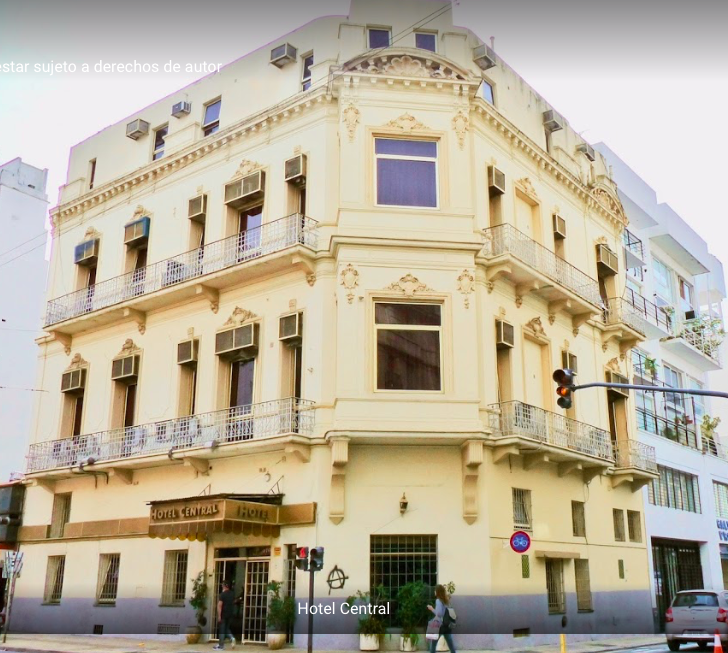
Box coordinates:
[0,0,728,480]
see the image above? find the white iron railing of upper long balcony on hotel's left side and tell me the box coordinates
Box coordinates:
[45,213,318,326]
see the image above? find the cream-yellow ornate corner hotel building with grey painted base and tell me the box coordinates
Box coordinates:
[14,0,657,648]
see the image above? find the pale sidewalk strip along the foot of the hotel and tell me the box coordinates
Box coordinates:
[0,633,665,653]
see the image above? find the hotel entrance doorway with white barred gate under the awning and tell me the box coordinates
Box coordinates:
[211,547,270,644]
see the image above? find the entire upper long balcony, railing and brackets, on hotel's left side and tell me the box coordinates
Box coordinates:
[45,214,317,334]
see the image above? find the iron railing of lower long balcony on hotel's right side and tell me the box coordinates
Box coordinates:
[489,401,614,461]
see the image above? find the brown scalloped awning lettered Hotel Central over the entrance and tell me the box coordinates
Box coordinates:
[149,494,316,541]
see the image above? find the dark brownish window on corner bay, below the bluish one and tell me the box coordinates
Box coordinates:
[374,302,442,391]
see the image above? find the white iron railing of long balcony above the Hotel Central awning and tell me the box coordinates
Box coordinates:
[27,397,314,474]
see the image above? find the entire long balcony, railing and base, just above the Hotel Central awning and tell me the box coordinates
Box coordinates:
[26,398,314,479]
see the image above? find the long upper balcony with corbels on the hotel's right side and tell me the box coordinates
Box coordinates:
[482,224,602,328]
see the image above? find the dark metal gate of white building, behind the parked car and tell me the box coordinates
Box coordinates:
[652,538,704,631]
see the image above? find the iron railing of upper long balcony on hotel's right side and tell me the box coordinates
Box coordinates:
[483,224,602,306]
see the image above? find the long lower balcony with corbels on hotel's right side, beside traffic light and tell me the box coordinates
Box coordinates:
[489,401,614,481]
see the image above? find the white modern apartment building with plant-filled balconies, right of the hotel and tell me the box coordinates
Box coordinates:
[596,144,728,629]
